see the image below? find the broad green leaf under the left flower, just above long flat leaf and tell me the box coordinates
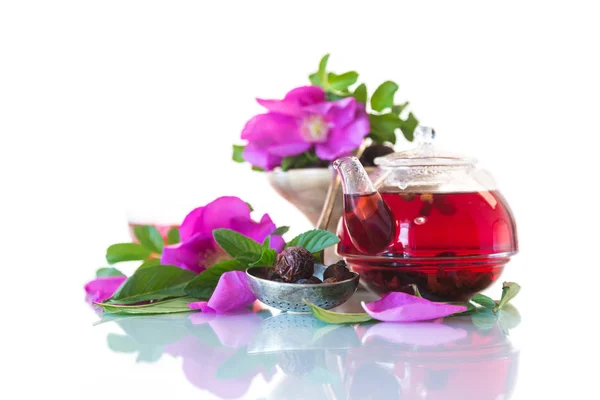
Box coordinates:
[109,265,196,304]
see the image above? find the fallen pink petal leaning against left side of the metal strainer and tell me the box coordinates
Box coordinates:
[189,271,256,314]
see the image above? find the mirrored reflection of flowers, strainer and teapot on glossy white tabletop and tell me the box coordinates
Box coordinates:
[86,294,519,400]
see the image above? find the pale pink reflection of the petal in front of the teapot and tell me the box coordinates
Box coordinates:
[362,322,467,346]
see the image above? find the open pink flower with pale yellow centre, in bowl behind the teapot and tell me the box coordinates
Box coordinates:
[242,86,369,170]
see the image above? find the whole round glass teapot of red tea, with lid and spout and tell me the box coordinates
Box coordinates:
[334,127,518,301]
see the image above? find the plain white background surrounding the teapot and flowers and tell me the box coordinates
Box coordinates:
[0,0,600,399]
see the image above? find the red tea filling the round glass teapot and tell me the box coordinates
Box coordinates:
[338,191,518,301]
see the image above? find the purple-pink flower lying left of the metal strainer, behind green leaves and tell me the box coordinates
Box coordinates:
[161,196,284,273]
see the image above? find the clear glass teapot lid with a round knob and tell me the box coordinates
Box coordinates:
[374,126,477,168]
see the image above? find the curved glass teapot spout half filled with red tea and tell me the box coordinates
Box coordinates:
[333,157,396,255]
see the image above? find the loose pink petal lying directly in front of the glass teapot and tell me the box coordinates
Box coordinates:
[361,292,467,322]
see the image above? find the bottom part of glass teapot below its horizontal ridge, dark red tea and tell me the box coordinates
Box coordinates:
[345,256,510,301]
